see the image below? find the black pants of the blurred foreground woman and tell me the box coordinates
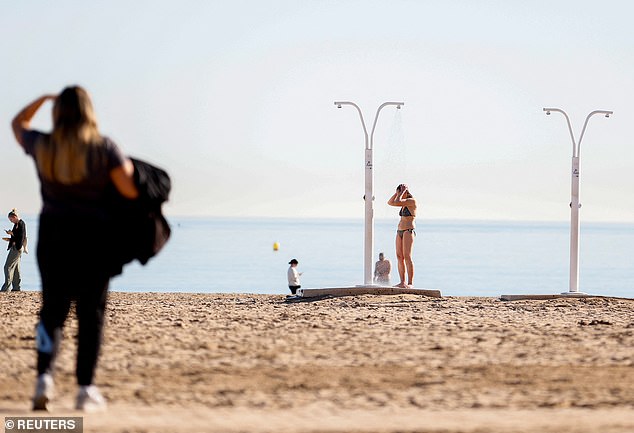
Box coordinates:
[37,213,110,385]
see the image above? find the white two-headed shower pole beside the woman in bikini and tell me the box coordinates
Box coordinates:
[335,101,405,286]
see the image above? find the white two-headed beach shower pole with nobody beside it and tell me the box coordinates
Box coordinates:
[544,108,612,294]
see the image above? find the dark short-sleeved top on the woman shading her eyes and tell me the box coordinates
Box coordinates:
[22,130,125,218]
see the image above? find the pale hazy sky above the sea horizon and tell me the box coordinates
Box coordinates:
[0,0,634,222]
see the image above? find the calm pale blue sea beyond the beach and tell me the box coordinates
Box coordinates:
[11,216,634,297]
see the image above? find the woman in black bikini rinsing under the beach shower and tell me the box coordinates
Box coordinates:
[387,184,416,288]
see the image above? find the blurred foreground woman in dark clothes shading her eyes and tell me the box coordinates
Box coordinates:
[11,86,139,411]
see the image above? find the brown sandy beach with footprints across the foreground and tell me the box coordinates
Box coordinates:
[0,292,634,433]
